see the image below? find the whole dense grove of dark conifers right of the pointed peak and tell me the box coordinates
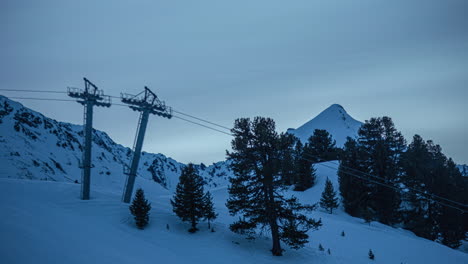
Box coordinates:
[338,117,468,248]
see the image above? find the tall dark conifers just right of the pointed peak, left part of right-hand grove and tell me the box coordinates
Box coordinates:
[338,117,406,224]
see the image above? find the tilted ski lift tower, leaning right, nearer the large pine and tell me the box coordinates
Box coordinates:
[121,86,172,203]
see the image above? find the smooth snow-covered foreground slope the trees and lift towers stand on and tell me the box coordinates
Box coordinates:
[0,162,468,264]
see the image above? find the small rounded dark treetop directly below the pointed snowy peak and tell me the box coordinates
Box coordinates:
[305,129,338,163]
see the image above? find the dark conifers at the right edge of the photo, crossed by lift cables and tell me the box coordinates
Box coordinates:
[402,135,468,248]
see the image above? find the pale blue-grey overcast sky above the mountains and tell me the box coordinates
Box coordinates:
[0,0,468,164]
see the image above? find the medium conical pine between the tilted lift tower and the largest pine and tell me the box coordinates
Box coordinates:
[171,163,205,233]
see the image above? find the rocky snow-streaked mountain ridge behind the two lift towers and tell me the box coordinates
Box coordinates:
[0,95,229,190]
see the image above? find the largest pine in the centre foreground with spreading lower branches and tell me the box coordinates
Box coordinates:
[226,117,321,256]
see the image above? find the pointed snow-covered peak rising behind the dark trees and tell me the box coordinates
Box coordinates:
[288,104,362,147]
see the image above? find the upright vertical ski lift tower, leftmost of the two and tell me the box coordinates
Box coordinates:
[68,78,111,200]
